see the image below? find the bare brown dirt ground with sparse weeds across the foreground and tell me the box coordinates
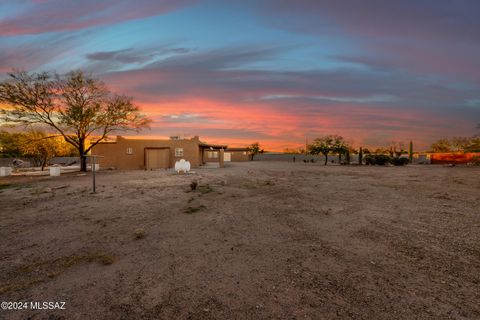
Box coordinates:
[0,162,480,319]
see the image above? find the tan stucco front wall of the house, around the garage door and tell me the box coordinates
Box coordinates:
[92,137,200,170]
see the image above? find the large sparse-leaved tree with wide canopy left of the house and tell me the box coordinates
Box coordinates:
[0,71,150,171]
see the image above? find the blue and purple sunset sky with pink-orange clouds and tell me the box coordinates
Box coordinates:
[0,0,480,151]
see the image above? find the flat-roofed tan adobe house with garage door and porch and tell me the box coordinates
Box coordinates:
[92,136,227,170]
